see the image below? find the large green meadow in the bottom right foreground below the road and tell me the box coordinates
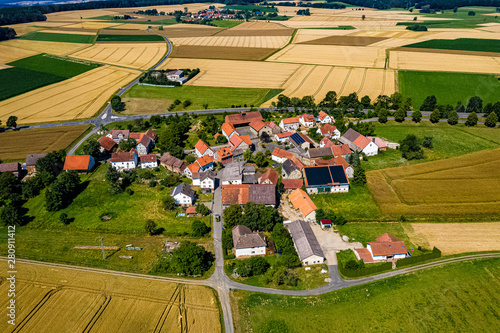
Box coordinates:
[230,259,500,333]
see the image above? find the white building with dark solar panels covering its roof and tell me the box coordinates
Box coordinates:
[304,165,349,194]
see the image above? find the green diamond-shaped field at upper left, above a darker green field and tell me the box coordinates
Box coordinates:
[7,54,99,79]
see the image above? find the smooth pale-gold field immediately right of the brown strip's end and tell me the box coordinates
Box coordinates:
[267,44,386,68]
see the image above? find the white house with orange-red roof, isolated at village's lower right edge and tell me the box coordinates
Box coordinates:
[354,233,409,262]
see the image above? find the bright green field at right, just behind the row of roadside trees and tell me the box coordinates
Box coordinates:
[398,70,500,108]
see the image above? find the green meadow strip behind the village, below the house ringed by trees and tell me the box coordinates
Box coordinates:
[124,85,281,111]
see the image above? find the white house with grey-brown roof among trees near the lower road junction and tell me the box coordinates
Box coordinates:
[232,225,267,258]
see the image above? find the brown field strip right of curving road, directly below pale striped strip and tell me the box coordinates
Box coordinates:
[170,45,278,60]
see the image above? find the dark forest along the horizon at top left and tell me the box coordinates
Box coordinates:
[0,0,258,25]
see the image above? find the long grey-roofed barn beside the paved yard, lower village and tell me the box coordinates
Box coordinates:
[288,220,325,260]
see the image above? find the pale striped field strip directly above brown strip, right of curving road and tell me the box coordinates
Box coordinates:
[172,35,290,48]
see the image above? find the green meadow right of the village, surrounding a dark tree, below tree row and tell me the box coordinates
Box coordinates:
[363,121,500,171]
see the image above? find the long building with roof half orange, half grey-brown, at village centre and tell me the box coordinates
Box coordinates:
[221,184,276,207]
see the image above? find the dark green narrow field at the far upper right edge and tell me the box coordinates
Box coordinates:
[403,38,500,52]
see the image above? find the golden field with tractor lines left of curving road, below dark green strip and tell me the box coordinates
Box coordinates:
[71,43,167,69]
